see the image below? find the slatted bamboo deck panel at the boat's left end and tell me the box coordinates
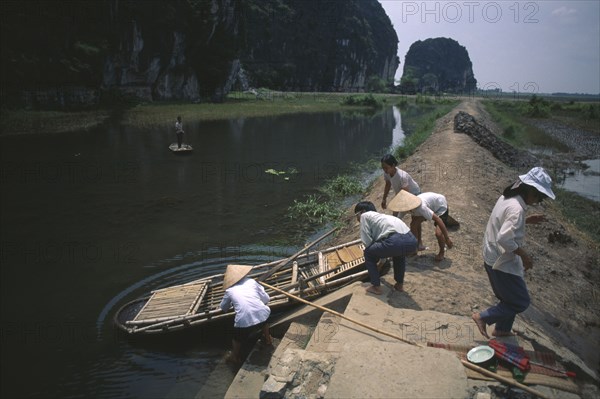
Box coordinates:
[131,281,209,324]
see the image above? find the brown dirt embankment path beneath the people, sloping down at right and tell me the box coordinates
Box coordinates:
[336,99,600,380]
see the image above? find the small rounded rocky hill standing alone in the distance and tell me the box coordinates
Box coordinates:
[400,37,477,94]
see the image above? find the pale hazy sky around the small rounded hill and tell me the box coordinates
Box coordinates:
[379,0,600,94]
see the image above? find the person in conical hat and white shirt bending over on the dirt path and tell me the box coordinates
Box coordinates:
[389,191,457,262]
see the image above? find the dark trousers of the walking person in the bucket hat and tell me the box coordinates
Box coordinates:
[480,264,531,332]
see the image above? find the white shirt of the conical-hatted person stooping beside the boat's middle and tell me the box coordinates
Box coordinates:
[220,277,271,328]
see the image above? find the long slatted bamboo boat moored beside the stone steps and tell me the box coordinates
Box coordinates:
[114,240,367,335]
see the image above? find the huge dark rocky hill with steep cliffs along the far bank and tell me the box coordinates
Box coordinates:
[0,0,398,108]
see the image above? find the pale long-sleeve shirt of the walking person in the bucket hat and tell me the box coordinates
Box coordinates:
[483,195,527,277]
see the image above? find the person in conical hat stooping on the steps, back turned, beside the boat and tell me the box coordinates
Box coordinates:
[220,265,273,365]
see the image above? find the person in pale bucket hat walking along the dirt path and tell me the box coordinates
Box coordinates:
[471,167,555,338]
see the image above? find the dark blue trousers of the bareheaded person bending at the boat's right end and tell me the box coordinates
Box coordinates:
[365,232,417,286]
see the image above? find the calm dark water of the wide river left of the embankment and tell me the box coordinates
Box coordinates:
[0,108,402,398]
